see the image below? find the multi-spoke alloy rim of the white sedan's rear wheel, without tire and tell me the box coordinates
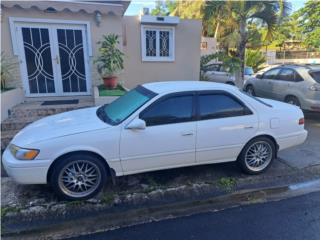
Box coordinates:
[245,141,273,172]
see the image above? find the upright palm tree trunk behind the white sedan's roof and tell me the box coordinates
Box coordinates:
[236,18,247,89]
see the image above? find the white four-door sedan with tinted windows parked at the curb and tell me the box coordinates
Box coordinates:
[3,81,307,200]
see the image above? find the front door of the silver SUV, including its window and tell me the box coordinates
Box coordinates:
[255,68,280,98]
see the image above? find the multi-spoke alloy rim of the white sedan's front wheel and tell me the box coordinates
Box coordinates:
[58,160,101,198]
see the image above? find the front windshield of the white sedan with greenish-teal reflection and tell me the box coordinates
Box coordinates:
[97,86,156,125]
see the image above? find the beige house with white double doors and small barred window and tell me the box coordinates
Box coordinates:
[1,0,201,101]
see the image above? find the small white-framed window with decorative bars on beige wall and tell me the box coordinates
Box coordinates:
[141,26,174,61]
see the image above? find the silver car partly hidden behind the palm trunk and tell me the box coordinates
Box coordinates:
[202,63,254,85]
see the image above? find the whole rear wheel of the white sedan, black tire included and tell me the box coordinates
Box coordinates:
[237,137,276,175]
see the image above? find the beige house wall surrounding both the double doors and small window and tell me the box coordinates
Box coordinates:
[1,6,201,94]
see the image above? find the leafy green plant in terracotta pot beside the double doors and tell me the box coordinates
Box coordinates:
[95,34,124,89]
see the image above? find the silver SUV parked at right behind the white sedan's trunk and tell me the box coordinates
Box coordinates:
[244,65,320,112]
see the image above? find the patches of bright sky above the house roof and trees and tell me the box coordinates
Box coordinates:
[125,0,306,16]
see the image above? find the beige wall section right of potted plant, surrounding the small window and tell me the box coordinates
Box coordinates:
[121,16,201,88]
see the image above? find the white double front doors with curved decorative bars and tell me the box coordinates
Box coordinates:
[17,24,90,97]
